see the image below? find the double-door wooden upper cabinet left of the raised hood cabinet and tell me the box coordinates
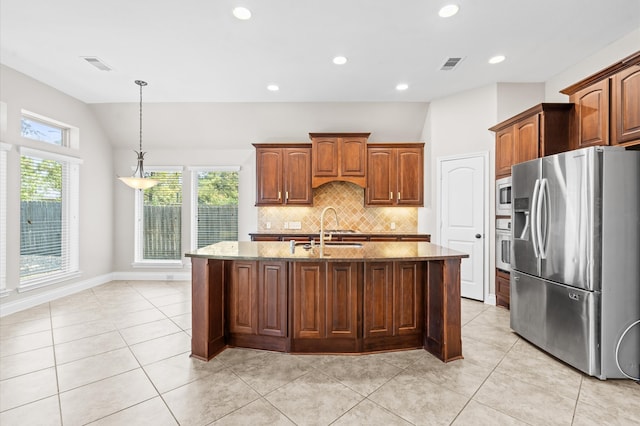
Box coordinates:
[254,144,313,206]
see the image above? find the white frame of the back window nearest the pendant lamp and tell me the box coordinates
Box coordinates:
[131,166,186,268]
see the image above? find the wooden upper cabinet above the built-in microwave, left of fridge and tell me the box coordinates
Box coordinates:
[489,103,573,178]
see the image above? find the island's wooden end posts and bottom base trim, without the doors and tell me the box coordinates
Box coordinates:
[191,258,462,362]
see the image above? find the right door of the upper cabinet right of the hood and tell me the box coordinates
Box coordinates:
[395,148,424,206]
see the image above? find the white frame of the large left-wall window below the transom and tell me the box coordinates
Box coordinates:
[17,146,83,292]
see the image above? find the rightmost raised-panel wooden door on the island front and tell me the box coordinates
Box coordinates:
[393,262,426,335]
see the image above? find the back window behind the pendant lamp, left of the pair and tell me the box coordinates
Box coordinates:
[135,168,183,263]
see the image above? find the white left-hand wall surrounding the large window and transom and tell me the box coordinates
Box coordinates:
[0,66,114,311]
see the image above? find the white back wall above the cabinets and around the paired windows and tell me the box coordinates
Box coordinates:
[109,102,428,278]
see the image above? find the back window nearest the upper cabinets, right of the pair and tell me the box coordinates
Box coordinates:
[191,167,240,249]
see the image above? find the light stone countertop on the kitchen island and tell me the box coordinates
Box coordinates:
[186,241,469,262]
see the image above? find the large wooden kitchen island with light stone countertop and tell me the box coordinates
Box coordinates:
[187,241,468,362]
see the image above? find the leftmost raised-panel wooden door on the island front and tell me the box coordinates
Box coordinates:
[229,261,258,334]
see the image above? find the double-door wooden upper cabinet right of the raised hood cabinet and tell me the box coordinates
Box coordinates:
[365,143,424,206]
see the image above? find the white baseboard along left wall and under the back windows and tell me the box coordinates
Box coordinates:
[0,272,191,317]
